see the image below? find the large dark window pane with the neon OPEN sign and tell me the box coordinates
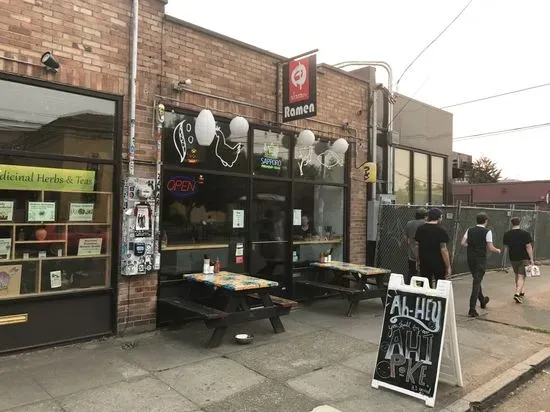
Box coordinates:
[161,170,249,279]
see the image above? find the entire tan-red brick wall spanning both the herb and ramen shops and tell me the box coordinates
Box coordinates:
[0,0,374,338]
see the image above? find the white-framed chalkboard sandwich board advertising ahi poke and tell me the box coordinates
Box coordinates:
[372,274,463,407]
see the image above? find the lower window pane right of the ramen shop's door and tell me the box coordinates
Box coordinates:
[292,183,345,266]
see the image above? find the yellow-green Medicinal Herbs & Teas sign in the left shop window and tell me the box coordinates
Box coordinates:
[0,164,95,192]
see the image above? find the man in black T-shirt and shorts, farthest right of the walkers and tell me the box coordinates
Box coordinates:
[502,217,535,303]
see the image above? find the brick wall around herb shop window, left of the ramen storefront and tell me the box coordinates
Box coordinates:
[0,0,165,331]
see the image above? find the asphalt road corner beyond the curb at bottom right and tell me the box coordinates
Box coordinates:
[490,369,550,412]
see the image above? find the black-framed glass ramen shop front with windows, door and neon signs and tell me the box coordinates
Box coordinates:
[155,107,349,323]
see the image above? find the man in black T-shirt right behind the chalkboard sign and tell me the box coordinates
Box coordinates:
[414,208,451,284]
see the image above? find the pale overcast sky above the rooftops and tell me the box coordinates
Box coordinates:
[166,0,550,180]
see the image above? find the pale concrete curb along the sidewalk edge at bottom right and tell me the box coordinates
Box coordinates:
[443,347,550,412]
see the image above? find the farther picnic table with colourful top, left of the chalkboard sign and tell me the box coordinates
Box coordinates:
[295,261,391,316]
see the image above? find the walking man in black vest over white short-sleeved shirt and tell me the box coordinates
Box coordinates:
[461,213,500,318]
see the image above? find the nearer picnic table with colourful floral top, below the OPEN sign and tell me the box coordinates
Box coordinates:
[159,271,296,347]
